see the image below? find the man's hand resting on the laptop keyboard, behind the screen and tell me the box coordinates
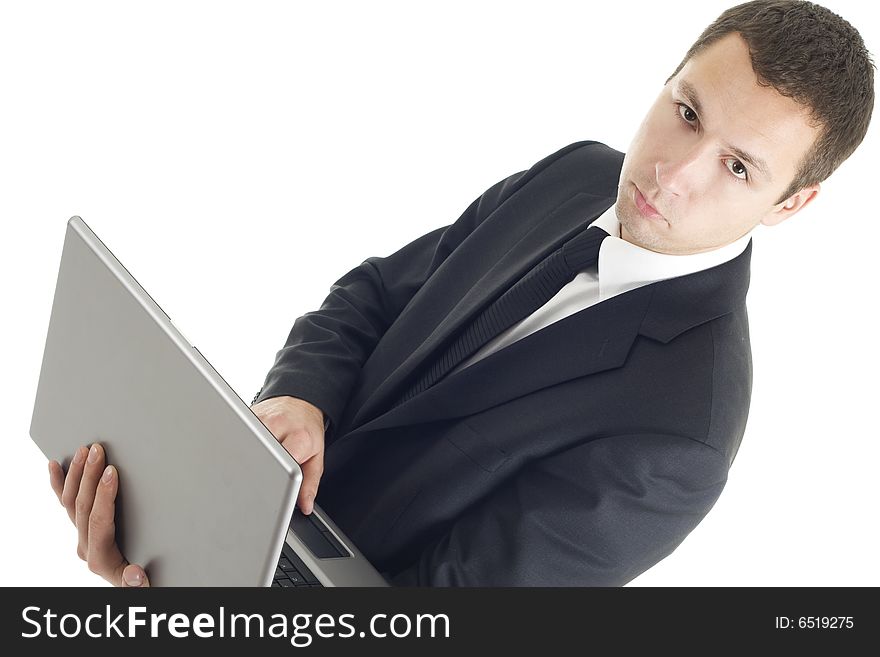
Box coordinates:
[251,397,324,515]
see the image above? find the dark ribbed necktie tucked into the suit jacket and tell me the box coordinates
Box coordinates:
[394,226,608,406]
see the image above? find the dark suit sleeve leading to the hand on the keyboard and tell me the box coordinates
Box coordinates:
[251,169,531,428]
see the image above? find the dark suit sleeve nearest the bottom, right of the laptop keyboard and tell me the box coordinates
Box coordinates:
[383,434,728,586]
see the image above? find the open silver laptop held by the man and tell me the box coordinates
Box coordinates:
[30,217,388,587]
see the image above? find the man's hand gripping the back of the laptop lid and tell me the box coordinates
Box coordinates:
[49,443,150,586]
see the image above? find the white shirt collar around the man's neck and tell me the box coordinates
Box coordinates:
[590,203,751,300]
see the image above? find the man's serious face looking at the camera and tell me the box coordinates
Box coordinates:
[616,33,819,254]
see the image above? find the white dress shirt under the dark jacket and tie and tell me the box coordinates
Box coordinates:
[450,204,751,374]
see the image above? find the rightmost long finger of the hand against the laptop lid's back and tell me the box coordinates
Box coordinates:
[86,465,128,586]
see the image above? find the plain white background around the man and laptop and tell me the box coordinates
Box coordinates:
[0,0,880,586]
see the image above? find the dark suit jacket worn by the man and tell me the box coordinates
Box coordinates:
[256,141,752,586]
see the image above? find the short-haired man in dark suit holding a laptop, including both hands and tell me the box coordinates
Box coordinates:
[49,0,874,586]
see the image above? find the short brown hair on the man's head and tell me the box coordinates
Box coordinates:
[666,0,874,204]
